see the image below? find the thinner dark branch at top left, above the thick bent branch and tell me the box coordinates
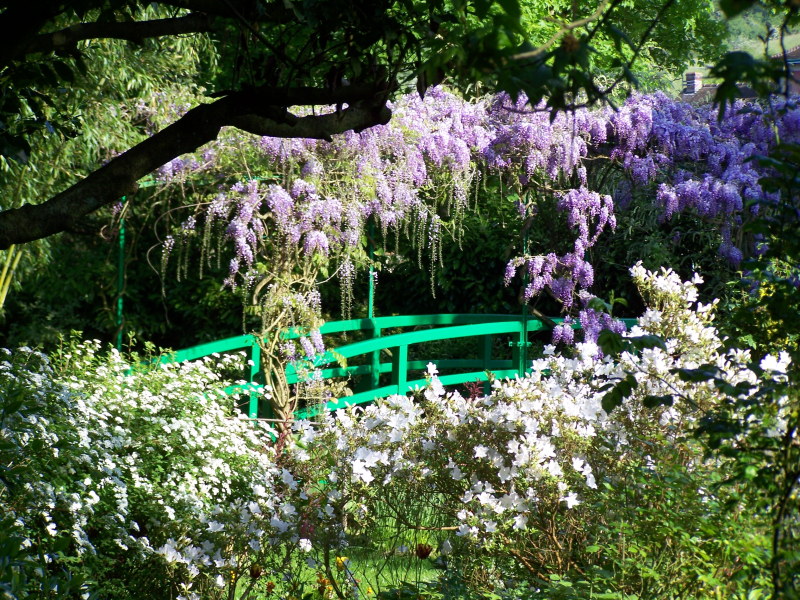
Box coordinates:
[19,13,211,58]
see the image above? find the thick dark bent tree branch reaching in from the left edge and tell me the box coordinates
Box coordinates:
[0,86,391,249]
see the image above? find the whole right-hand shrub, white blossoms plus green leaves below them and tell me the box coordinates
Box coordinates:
[290,265,772,597]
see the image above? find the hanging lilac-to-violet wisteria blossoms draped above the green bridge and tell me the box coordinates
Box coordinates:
[153,88,800,319]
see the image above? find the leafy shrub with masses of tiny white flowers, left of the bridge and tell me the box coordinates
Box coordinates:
[0,342,304,598]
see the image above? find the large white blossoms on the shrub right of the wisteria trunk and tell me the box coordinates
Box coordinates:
[292,264,788,560]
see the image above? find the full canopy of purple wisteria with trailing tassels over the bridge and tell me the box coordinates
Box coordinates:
[152,88,798,338]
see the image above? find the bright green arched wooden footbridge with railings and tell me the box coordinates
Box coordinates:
[162,314,635,419]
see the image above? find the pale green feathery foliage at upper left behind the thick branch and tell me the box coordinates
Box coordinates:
[0,2,213,314]
